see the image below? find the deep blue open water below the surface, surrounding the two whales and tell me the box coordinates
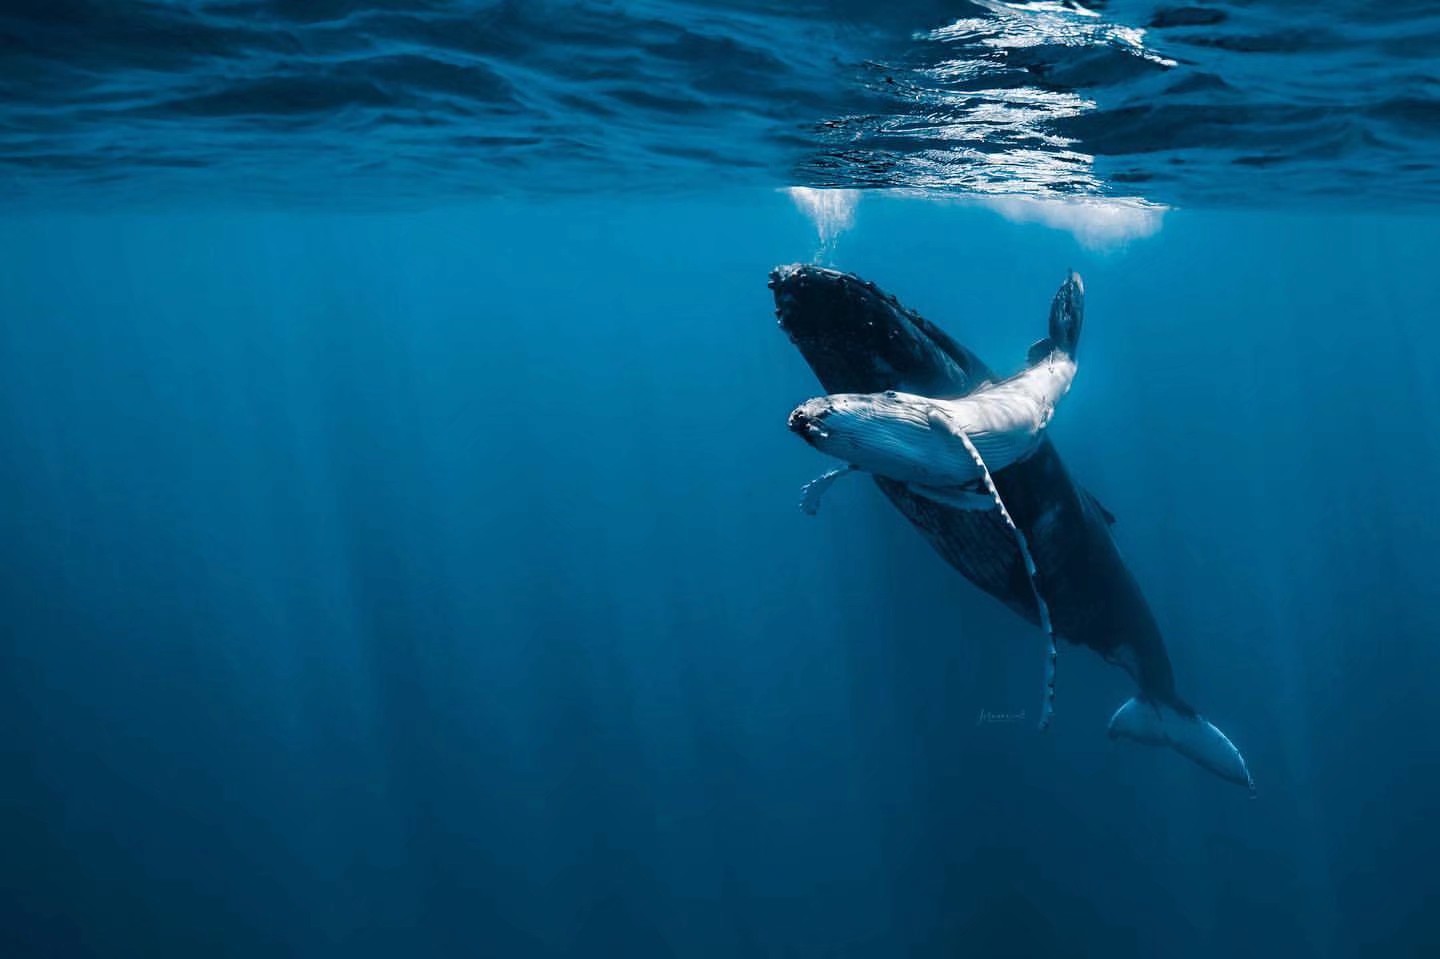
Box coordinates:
[0,193,1440,956]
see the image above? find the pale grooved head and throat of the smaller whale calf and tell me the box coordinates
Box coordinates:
[789,390,956,484]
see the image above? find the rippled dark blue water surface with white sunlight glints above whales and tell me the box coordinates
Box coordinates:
[0,0,1440,206]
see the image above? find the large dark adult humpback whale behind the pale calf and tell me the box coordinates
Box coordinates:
[770,257,1254,792]
